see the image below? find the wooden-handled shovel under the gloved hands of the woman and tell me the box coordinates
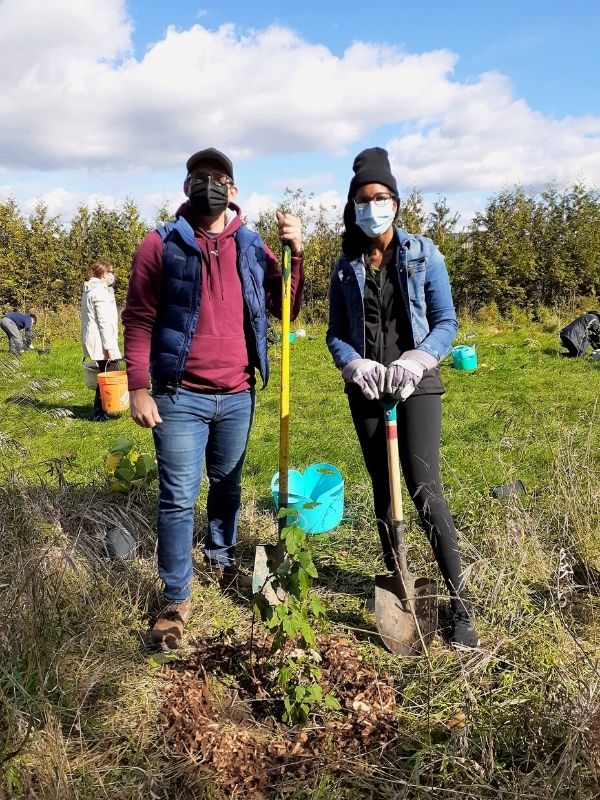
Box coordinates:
[375,398,437,656]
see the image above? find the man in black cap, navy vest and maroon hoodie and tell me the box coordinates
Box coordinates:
[122,148,304,648]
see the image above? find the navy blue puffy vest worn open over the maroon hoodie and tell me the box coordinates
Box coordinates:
[150,217,269,389]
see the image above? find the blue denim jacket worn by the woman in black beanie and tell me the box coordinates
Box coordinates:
[326,228,458,369]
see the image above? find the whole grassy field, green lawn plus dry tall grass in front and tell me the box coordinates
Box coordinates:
[0,310,600,800]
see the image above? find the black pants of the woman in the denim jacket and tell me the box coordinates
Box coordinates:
[348,390,463,597]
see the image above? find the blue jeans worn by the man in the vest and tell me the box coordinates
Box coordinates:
[152,388,254,603]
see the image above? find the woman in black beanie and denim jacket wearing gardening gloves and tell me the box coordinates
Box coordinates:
[327,147,479,648]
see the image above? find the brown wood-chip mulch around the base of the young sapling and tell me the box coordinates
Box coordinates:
[162,636,398,798]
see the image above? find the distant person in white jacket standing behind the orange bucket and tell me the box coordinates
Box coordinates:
[81,259,121,422]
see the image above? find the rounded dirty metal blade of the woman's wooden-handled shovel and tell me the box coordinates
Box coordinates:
[375,574,437,656]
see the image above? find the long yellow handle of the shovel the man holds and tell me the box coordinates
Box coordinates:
[279,244,292,531]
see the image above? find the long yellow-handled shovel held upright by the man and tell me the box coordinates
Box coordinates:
[252,244,292,605]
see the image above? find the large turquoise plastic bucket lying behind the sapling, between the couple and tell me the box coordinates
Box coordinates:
[271,463,344,533]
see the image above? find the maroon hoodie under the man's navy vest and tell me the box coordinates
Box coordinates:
[122,203,304,393]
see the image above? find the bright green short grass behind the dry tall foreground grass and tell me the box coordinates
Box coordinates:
[0,323,600,510]
